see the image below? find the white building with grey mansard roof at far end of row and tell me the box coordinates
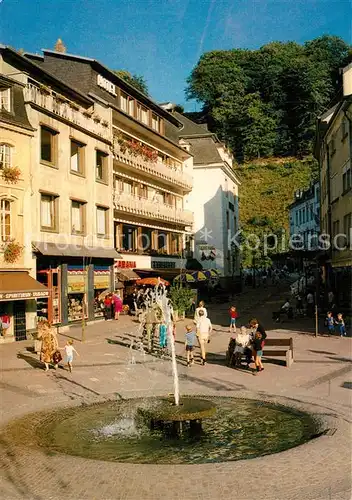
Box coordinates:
[164,103,240,277]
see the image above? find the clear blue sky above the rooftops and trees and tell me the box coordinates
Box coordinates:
[0,0,352,111]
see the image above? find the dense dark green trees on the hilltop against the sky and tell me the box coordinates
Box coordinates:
[186,36,351,160]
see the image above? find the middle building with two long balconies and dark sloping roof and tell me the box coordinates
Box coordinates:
[27,50,193,280]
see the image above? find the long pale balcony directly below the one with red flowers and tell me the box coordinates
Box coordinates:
[113,190,193,226]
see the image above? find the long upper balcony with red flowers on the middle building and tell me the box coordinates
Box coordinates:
[113,140,193,191]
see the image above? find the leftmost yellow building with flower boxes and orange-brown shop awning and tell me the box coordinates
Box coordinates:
[0,53,49,343]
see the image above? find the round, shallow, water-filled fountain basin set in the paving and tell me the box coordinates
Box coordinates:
[6,397,318,464]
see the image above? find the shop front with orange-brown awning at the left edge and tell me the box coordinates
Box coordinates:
[0,271,49,342]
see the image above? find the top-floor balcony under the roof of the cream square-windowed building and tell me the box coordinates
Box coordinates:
[24,83,110,140]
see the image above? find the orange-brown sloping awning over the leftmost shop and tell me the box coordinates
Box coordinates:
[0,271,49,302]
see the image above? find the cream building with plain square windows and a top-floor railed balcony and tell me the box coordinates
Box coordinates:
[1,47,118,336]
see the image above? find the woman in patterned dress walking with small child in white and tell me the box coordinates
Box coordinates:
[37,321,79,372]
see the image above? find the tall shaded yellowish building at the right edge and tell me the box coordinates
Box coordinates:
[316,59,352,308]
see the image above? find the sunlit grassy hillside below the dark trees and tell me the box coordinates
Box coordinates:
[236,157,317,267]
